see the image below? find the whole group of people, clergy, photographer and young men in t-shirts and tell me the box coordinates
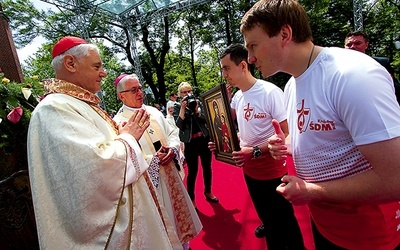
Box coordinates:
[28,0,400,250]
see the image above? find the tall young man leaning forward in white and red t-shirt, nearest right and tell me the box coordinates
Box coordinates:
[240,0,400,249]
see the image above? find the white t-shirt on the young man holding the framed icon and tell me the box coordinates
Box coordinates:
[231,79,286,147]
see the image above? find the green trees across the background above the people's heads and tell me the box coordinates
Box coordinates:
[3,0,400,101]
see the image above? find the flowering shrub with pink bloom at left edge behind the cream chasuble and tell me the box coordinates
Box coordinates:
[0,69,43,180]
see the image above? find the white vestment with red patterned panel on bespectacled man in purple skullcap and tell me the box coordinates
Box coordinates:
[114,105,202,244]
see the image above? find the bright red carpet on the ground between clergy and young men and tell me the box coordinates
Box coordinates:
[185,155,314,250]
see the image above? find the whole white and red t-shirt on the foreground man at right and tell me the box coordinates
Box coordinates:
[285,48,400,249]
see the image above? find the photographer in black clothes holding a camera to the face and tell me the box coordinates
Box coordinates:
[174,82,219,207]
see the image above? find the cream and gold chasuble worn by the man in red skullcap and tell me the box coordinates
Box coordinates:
[28,79,182,249]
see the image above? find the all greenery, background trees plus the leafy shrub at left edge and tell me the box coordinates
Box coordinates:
[0,0,400,184]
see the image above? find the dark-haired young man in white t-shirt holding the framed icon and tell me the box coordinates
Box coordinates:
[209,44,304,249]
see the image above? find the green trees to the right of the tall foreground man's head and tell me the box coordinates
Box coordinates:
[300,0,400,80]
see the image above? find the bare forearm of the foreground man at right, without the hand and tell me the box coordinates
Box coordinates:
[304,137,400,204]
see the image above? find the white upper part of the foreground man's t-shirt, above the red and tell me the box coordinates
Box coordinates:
[285,48,400,182]
